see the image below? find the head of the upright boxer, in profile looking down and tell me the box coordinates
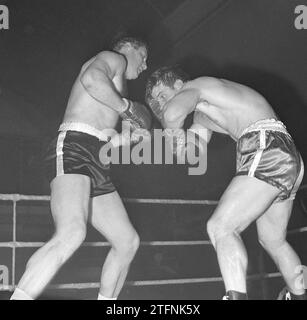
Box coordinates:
[113,37,148,80]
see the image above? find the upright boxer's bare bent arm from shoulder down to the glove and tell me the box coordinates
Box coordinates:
[80,52,127,113]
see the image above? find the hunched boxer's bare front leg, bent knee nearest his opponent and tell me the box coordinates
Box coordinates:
[207,176,280,293]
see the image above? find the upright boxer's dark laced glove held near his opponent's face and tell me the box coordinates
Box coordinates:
[120,98,152,130]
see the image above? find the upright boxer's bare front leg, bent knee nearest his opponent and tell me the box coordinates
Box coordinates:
[91,191,139,298]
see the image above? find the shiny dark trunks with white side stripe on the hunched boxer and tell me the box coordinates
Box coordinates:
[236,119,304,201]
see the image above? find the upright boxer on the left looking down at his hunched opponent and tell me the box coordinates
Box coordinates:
[11,37,151,300]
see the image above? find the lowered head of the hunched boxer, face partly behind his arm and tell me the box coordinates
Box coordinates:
[145,66,188,120]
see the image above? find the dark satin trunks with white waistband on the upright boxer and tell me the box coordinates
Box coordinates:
[44,122,115,197]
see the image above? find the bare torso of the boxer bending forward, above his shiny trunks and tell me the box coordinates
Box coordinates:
[159,77,277,140]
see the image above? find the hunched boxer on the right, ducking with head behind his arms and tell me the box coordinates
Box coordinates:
[146,67,306,300]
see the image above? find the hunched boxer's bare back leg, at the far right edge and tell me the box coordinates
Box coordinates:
[257,201,305,295]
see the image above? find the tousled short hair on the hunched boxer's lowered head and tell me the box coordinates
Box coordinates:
[145,65,189,105]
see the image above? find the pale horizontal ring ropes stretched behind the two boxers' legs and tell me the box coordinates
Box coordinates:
[0,189,307,291]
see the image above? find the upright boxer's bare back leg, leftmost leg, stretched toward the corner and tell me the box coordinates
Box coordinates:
[12,174,90,299]
